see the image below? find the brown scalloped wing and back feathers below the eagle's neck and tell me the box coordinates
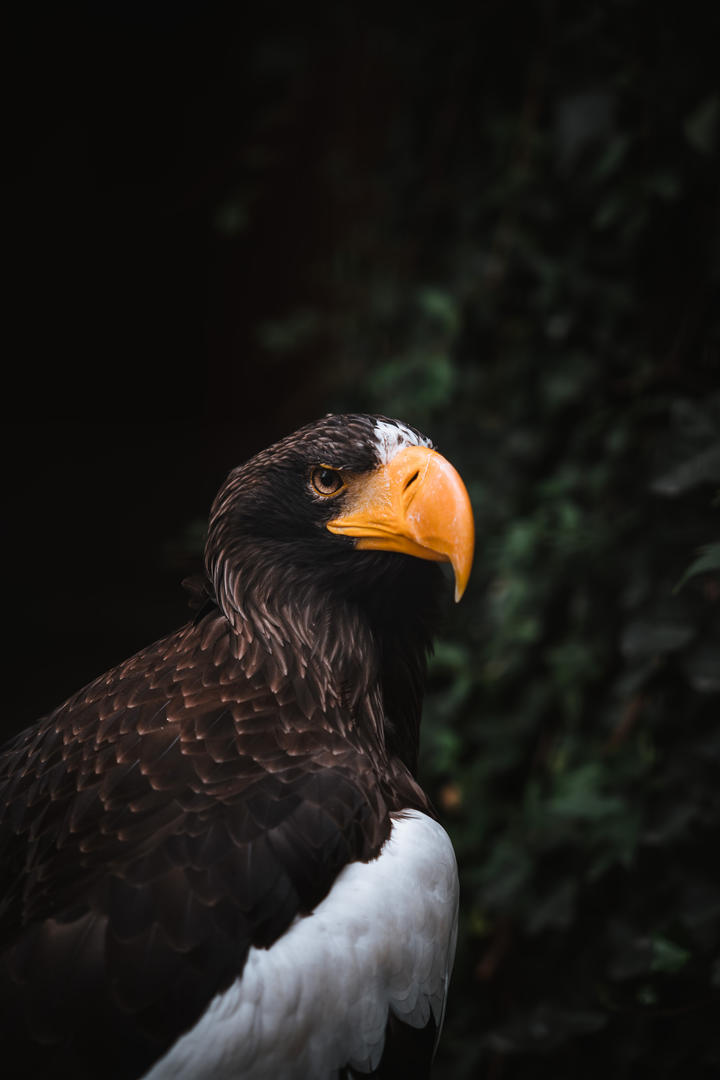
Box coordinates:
[0,612,397,1077]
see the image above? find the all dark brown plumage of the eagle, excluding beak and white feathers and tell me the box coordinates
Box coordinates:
[0,417,472,1078]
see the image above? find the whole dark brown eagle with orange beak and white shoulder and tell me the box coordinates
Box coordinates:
[0,414,474,1080]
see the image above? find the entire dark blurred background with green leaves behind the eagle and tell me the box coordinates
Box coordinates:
[1,0,720,1080]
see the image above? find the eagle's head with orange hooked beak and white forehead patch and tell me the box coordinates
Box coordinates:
[206,414,474,612]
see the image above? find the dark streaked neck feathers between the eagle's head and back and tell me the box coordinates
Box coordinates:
[208,537,443,775]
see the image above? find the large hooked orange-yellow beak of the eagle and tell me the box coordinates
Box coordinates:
[327,446,475,600]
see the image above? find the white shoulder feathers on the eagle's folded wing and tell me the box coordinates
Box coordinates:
[147,811,458,1080]
